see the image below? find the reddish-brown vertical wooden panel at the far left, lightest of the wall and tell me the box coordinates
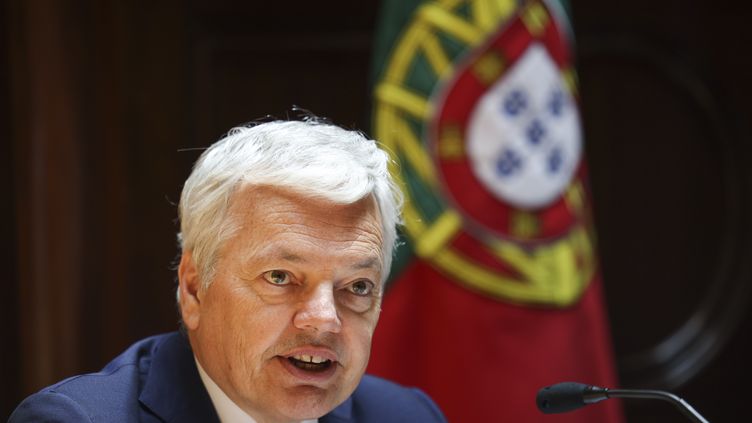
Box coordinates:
[9,1,83,398]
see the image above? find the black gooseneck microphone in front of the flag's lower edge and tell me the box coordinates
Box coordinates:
[535,382,709,423]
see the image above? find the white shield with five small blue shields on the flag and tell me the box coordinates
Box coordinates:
[467,44,582,210]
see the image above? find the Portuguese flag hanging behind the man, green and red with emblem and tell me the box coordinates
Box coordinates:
[368,0,622,423]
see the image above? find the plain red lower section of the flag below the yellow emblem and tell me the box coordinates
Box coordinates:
[368,260,622,423]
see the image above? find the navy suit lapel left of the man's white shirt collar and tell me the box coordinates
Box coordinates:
[139,332,219,422]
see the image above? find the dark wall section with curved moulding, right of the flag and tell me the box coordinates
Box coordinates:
[573,0,752,422]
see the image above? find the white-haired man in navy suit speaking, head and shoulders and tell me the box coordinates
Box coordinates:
[10,121,444,423]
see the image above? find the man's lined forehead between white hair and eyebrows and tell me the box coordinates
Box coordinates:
[227,186,384,271]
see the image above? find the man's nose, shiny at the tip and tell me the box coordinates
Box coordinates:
[293,283,342,333]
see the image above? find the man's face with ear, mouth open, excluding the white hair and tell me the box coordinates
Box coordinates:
[179,187,385,422]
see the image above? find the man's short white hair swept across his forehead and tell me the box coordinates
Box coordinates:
[178,120,402,287]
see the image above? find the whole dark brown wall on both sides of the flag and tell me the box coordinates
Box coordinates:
[0,0,752,422]
